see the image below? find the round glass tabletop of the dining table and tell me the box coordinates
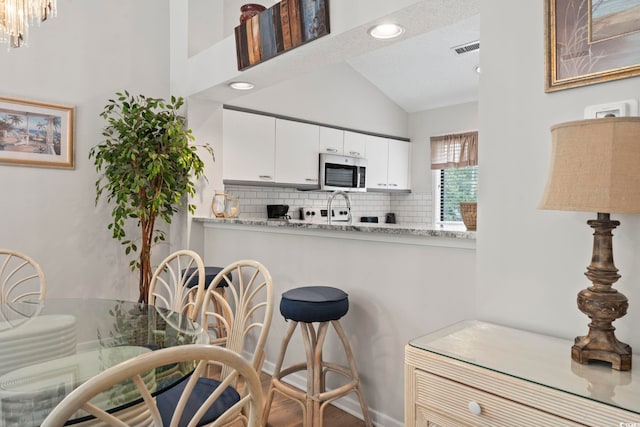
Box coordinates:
[0,299,208,427]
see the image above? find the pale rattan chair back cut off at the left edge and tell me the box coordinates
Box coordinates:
[0,249,47,304]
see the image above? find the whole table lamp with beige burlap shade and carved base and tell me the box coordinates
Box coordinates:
[540,117,640,371]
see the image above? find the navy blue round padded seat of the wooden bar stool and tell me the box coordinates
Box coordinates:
[280,286,349,323]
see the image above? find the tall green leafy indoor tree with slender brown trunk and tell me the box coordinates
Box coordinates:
[89,91,213,303]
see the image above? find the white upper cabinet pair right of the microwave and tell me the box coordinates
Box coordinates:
[367,136,410,191]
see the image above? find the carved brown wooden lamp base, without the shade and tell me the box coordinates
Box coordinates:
[571,213,631,371]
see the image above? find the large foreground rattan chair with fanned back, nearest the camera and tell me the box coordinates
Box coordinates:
[42,344,264,427]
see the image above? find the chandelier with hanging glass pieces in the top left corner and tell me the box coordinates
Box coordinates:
[0,0,57,48]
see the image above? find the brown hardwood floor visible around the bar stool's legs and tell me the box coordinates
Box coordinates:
[260,373,364,427]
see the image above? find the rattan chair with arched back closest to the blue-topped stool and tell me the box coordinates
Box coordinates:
[200,260,273,376]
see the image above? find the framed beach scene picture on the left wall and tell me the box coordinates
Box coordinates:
[0,97,73,169]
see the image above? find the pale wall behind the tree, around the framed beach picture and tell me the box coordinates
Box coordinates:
[0,0,169,299]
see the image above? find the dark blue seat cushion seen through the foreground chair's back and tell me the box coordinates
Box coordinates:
[156,377,240,427]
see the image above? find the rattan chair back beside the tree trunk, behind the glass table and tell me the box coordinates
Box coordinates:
[149,249,205,321]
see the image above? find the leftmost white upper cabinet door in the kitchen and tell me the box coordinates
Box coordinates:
[222,109,276,182]
